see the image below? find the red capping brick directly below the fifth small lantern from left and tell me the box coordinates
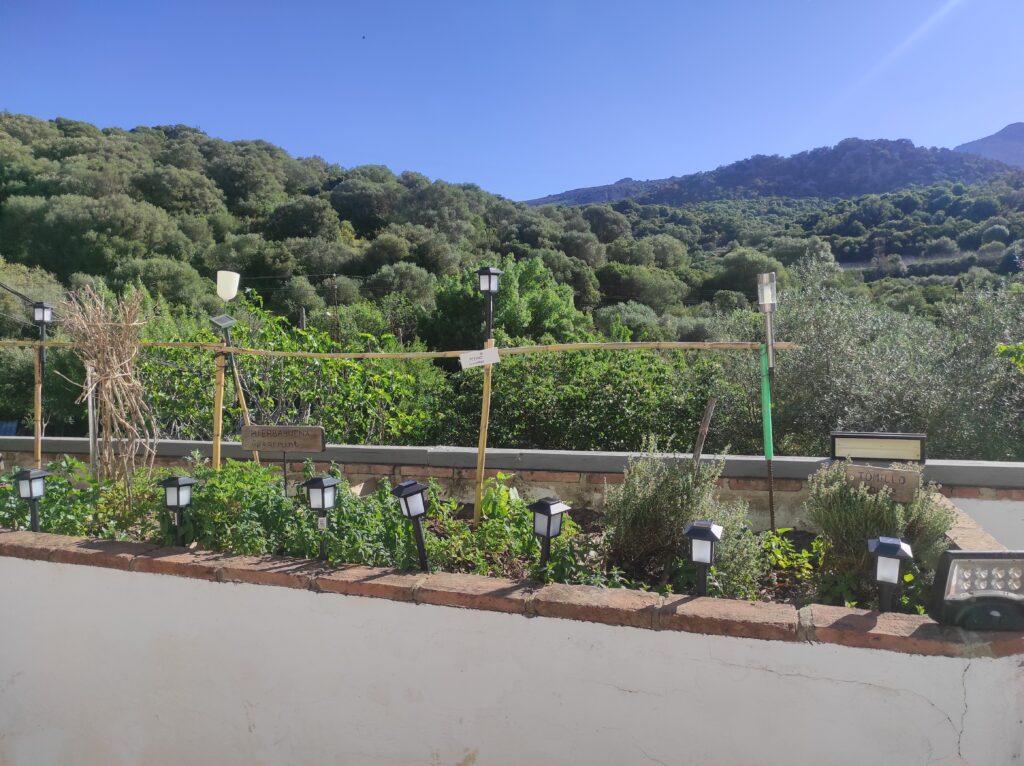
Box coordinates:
[530,583,663,628]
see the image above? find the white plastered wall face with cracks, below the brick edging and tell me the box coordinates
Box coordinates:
[0,557,1024,766]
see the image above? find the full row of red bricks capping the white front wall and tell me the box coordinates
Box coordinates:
[0,529,1024,657]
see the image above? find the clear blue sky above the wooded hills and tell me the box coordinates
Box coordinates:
[0,0,1024,200]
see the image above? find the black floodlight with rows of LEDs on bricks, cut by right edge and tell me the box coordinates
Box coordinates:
[931,551,1024,631]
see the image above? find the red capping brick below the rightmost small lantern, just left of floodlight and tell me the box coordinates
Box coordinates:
[801,604,974,656]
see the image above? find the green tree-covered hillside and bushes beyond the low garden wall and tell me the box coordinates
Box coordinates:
[0,114,1024,459]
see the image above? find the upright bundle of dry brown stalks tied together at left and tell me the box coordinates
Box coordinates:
[62,286,157,486]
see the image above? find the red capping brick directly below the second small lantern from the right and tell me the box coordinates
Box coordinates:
[657,596,799,641]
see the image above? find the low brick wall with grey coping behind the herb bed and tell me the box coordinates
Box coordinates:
[6,436,1024,529]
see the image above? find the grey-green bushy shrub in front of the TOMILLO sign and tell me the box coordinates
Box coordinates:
[805,462,953,601]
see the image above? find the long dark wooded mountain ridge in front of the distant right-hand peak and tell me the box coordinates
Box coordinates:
[527,136,1011,205]
